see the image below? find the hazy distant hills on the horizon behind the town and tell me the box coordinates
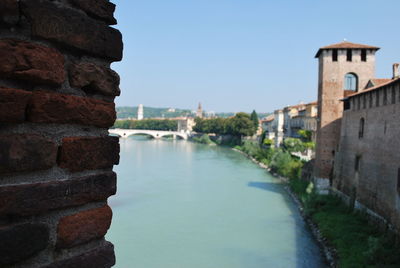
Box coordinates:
[116,106,270,119]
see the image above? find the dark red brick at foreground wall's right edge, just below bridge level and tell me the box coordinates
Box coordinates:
[58,137,119,172]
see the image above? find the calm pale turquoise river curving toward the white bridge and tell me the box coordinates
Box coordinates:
[106,137,326,268]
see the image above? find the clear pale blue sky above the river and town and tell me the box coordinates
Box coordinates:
[112,0,400,112]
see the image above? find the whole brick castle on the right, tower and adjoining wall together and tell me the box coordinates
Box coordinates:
[314,42,400,231]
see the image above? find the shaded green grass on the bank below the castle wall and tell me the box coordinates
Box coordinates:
[289,179,400,268]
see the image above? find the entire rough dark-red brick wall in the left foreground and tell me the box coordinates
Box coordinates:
[0,0,122,268]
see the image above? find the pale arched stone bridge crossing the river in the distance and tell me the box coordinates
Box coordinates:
[108,128,189,140]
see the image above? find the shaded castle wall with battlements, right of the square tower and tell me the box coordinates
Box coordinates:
[333,80,400,230]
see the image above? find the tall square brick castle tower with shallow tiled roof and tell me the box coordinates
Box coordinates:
[314,42,379,185]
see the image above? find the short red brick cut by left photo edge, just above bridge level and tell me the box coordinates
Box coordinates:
[0,87,32,123]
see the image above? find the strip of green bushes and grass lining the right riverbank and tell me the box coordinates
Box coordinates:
[192,116,400,268]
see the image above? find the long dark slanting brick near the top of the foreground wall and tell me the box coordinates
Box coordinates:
[21,0,122,61]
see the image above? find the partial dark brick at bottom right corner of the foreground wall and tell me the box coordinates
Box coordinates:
[43,242,115,268]
